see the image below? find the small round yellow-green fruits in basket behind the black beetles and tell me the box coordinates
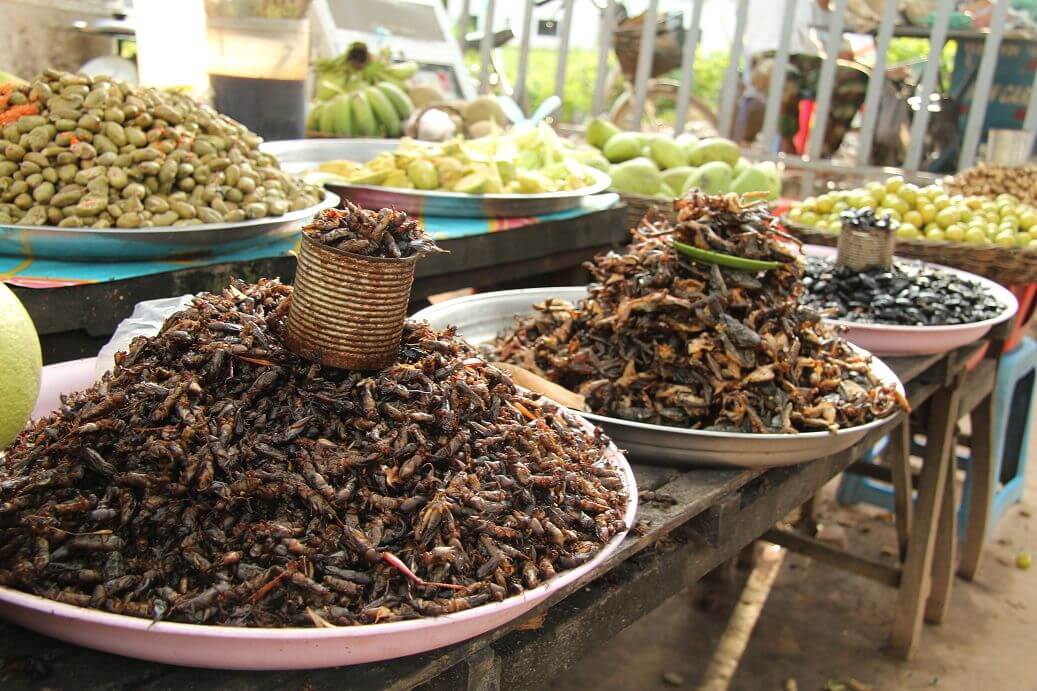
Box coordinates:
[787,176,1037,248]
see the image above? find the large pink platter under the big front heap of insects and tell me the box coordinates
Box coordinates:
[0,359,638,670]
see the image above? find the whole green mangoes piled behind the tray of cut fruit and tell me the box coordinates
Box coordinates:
[587,117,781,199]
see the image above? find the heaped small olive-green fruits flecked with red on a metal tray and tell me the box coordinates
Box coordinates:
[0,71,324,228]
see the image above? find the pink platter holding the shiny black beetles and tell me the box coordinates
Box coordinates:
[803,245,1019,357]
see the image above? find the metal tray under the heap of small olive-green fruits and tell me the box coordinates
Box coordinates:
[0,190,339,261]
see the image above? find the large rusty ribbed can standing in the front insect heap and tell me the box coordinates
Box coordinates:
[285,233,418,369]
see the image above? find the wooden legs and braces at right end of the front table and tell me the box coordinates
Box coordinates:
[764,324,1011,659]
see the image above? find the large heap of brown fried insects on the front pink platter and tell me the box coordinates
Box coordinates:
[0,280,626,627]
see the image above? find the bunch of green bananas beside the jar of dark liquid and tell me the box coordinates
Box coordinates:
[306,43,418,137]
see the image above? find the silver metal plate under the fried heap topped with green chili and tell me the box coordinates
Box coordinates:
[412,286,903,468]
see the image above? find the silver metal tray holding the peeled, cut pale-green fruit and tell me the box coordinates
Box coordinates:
[261,139,612,218]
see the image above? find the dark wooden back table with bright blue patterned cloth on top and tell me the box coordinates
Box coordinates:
[0,195,628,363]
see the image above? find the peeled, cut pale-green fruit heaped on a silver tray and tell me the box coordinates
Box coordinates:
[318,122,594,194]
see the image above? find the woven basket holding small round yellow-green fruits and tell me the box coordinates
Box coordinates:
[785,222,1037,285]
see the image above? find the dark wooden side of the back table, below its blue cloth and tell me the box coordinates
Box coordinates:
[13,205,629,364]
